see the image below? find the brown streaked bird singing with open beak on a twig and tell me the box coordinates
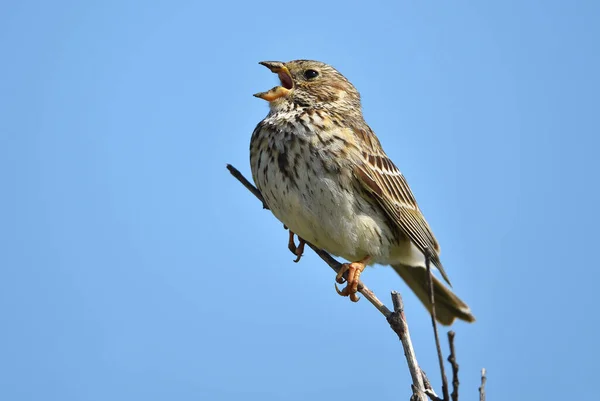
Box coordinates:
[250,60,475,325]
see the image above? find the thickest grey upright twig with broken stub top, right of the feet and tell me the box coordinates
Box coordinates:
[387,291,427,401]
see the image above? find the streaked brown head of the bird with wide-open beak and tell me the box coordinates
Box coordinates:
[254,60,360,112]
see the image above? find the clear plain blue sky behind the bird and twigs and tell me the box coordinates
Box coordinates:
[0,0,600,401]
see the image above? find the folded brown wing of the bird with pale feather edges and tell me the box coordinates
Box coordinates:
[354,127,450,284]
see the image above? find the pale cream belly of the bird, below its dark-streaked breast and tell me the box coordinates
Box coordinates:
[257,153,393,264]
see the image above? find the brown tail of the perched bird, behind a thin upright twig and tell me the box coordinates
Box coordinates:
[392,265,475,326]
